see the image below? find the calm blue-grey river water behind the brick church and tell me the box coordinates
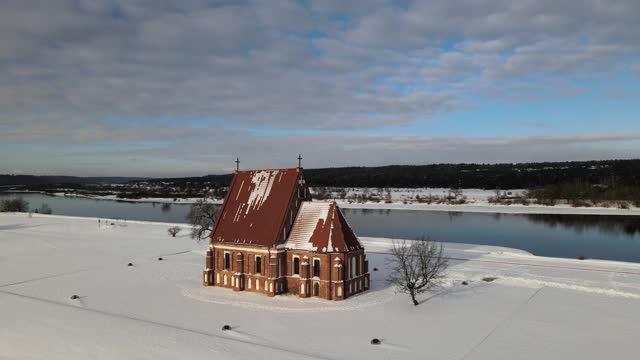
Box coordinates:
[0,193,640,263]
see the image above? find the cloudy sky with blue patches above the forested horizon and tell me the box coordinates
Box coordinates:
[0,0,640,176]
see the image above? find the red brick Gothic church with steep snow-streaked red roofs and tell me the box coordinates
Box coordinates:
[203,167,369,300]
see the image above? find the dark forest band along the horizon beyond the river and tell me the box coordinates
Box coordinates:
[0,160,640,202]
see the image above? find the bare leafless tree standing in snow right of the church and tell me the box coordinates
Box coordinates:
[387,237,448,306]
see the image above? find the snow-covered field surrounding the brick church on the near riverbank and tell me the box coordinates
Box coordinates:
[0,214,640,360]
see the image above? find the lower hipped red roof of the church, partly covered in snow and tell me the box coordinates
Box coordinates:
[285,202,362,252]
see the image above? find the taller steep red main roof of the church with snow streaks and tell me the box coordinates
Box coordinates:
[211,168,300,246]
